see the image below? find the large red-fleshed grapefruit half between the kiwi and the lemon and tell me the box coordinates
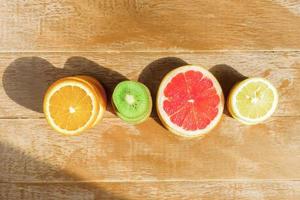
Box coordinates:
[156,65,224,137]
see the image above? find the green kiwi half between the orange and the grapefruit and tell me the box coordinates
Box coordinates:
[112,81,152,124]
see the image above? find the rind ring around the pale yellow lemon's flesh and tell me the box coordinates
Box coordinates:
[227,77,279,125]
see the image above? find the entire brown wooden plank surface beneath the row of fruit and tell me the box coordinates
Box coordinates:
[0,0,300,200]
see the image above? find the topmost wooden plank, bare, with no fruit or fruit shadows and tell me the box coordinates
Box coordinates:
[0,0,300,52]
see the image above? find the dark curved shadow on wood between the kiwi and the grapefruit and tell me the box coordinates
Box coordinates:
[138,57,188,123]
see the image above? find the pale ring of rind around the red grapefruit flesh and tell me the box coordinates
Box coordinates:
[156,65,224,138]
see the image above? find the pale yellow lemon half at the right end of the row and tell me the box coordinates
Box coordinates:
[227,78,278,124]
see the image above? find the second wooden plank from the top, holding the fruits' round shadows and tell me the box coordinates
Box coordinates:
[0,51,300,118]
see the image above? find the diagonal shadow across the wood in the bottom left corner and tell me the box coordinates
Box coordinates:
[0,143,125,200]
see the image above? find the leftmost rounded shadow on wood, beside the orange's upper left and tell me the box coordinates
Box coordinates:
[2,57,59,113]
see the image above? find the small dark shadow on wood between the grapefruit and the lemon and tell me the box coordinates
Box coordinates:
[209,64,247,117]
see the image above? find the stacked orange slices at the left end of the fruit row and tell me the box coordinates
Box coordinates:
[44,76,106,135]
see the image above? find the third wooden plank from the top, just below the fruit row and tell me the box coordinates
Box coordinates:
[0,117,300,181]
